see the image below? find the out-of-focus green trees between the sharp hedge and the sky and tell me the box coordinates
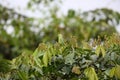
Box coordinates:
[0,0,120,59]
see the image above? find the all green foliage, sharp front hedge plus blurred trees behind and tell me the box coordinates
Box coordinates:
[0,0,120,80]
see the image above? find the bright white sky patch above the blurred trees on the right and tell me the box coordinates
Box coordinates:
[61,0,120,14]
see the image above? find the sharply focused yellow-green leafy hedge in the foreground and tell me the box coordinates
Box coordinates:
[0,34,120,80]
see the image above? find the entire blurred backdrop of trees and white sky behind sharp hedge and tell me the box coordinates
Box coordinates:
[0,0,120,59]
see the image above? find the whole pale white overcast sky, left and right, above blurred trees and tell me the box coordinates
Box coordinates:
[0,0,120,32]
